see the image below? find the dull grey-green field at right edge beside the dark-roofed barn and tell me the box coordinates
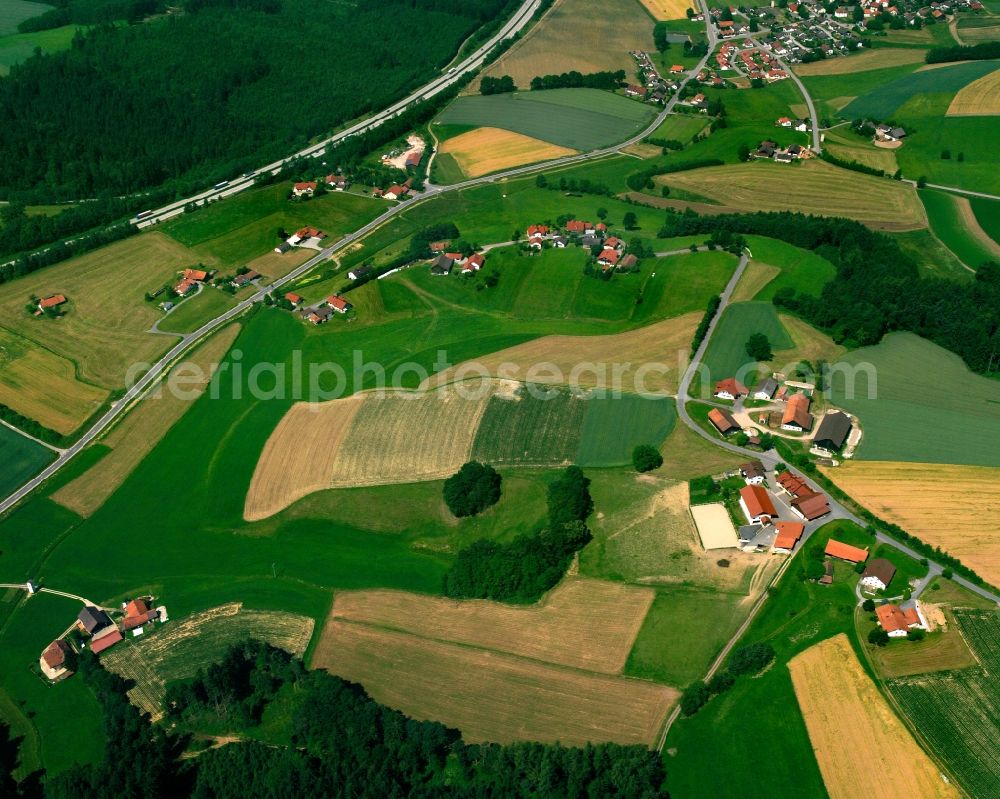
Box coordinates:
[831,333,1000,466]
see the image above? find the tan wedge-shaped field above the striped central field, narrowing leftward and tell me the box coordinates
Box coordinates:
[426,313,701,394]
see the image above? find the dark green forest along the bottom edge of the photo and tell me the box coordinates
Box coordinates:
[0,641,666,799]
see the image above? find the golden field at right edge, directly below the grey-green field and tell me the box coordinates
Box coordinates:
[824,462,1000,588]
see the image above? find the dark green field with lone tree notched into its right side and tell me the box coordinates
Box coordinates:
[704,302,794,383]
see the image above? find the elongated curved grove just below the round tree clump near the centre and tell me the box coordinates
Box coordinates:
[444,466,594,602]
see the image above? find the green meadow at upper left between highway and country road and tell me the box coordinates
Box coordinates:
[159,183,387,269]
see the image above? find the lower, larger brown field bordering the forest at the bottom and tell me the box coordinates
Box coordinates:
[311,619,679,746]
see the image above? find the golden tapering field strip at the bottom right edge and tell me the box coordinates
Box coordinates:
[788,634,960,799]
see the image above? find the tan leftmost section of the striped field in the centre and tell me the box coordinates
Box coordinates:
[243,395,365,521]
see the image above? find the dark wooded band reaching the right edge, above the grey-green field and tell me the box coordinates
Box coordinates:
[659,211,1000,374]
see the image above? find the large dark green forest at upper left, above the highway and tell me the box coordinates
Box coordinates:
[0,0,511,199]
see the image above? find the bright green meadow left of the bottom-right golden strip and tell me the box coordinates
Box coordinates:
[664,521,870,799]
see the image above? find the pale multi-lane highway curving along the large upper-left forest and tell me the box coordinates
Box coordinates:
[132,0,541,228]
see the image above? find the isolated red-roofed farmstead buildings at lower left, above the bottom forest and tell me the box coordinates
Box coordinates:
[38,597,167,682]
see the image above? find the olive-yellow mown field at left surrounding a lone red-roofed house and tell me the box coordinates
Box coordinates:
[0,231,199,388]
